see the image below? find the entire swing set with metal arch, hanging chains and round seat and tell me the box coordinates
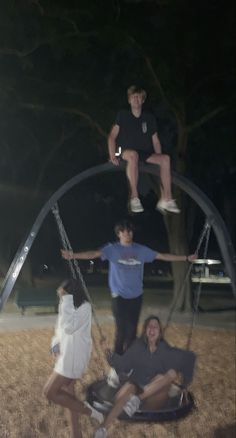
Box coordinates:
[0,163,236,421]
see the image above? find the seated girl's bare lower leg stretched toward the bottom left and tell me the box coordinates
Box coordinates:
[101,383,136,429]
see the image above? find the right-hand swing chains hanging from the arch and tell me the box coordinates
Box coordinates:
[164,220,211,349]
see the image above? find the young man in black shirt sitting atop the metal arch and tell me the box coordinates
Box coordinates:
[108,85,180,213]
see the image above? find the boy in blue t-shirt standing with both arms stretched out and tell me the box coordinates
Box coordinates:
[61,220,197,355]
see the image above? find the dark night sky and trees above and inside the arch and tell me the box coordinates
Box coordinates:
[0,0,236,273]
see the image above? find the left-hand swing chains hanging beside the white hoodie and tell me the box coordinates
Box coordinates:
[51,203,105,341]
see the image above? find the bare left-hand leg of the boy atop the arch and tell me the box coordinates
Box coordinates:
[122,149,139,198]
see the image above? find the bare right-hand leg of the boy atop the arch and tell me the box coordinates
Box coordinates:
[146,154,172,201]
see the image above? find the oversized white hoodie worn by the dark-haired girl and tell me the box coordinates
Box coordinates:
[51,294,92,379]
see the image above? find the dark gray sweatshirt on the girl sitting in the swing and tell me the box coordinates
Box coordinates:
[108,338,196,387]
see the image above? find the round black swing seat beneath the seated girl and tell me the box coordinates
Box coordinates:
[87,378,195,422]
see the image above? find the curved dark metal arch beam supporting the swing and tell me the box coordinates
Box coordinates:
[0,163,236,310]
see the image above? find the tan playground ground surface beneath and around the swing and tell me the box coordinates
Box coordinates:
[0,323,236,438]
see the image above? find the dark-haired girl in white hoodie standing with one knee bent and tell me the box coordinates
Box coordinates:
[43,279,103,438]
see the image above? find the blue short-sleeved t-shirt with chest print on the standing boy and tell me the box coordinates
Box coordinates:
[101,242,157,299]
